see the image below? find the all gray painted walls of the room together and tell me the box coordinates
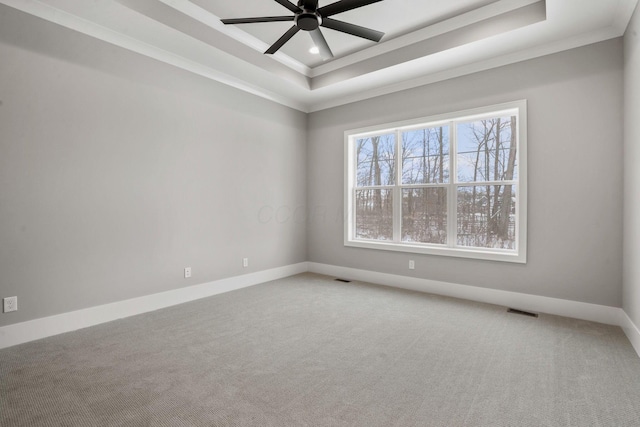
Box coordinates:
[0,6,640,332]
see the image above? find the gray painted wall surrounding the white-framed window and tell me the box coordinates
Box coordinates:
[308,39,623,307]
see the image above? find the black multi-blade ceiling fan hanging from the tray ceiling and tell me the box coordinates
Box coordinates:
[221,0,384,59]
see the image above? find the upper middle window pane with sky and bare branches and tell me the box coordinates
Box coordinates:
[402,126,449,184]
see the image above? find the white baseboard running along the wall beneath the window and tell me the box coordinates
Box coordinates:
[309,262,624,326]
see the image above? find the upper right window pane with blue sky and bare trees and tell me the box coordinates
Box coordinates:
[456,116,518,182]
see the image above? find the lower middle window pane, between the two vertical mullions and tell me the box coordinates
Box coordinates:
[402,187,447,244]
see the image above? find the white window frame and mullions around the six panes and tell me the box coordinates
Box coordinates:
[344,100,527,263]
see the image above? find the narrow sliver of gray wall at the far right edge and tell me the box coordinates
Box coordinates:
[624,7,640,327]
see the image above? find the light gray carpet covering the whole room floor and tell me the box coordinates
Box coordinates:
[0,274,640,427]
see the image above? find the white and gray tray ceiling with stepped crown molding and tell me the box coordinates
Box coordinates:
[0,0,638,112]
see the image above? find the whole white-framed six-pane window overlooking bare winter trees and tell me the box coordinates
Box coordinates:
[345,101,527,263]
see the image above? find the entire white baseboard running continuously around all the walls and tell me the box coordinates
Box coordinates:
[0,262,640,356]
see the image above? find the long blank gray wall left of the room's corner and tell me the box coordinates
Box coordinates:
[0,6,307,326]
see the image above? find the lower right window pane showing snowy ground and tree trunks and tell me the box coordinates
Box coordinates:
[457,185,516,249]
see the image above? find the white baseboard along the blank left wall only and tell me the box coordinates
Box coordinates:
[0,262,308,348]
